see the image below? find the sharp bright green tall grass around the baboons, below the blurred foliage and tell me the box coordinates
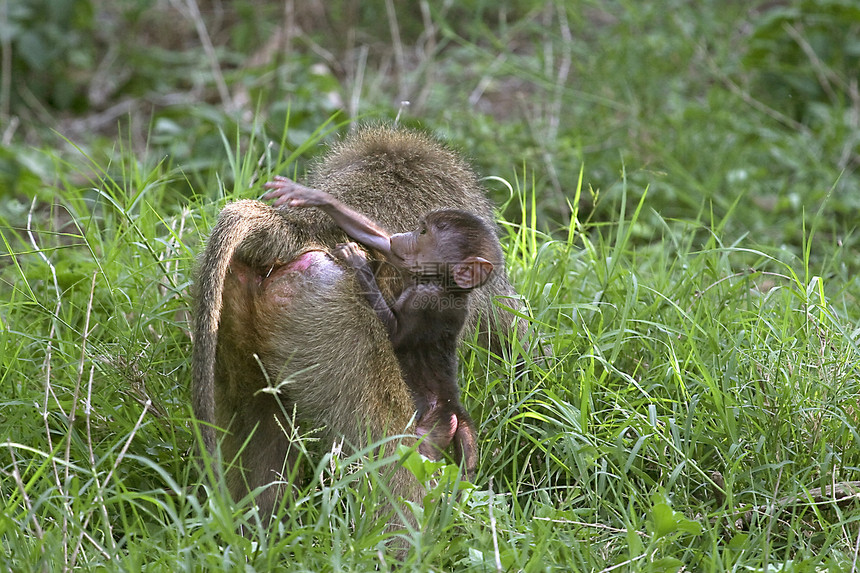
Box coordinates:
[0,137,860,571]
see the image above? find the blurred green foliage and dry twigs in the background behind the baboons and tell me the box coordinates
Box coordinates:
[0,0,860,270]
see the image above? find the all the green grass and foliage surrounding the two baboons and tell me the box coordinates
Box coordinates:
[0,0,860,571]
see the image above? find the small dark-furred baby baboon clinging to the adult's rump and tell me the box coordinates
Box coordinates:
[263,177,503,478]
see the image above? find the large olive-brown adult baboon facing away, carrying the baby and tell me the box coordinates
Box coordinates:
[192,123,524,514]
